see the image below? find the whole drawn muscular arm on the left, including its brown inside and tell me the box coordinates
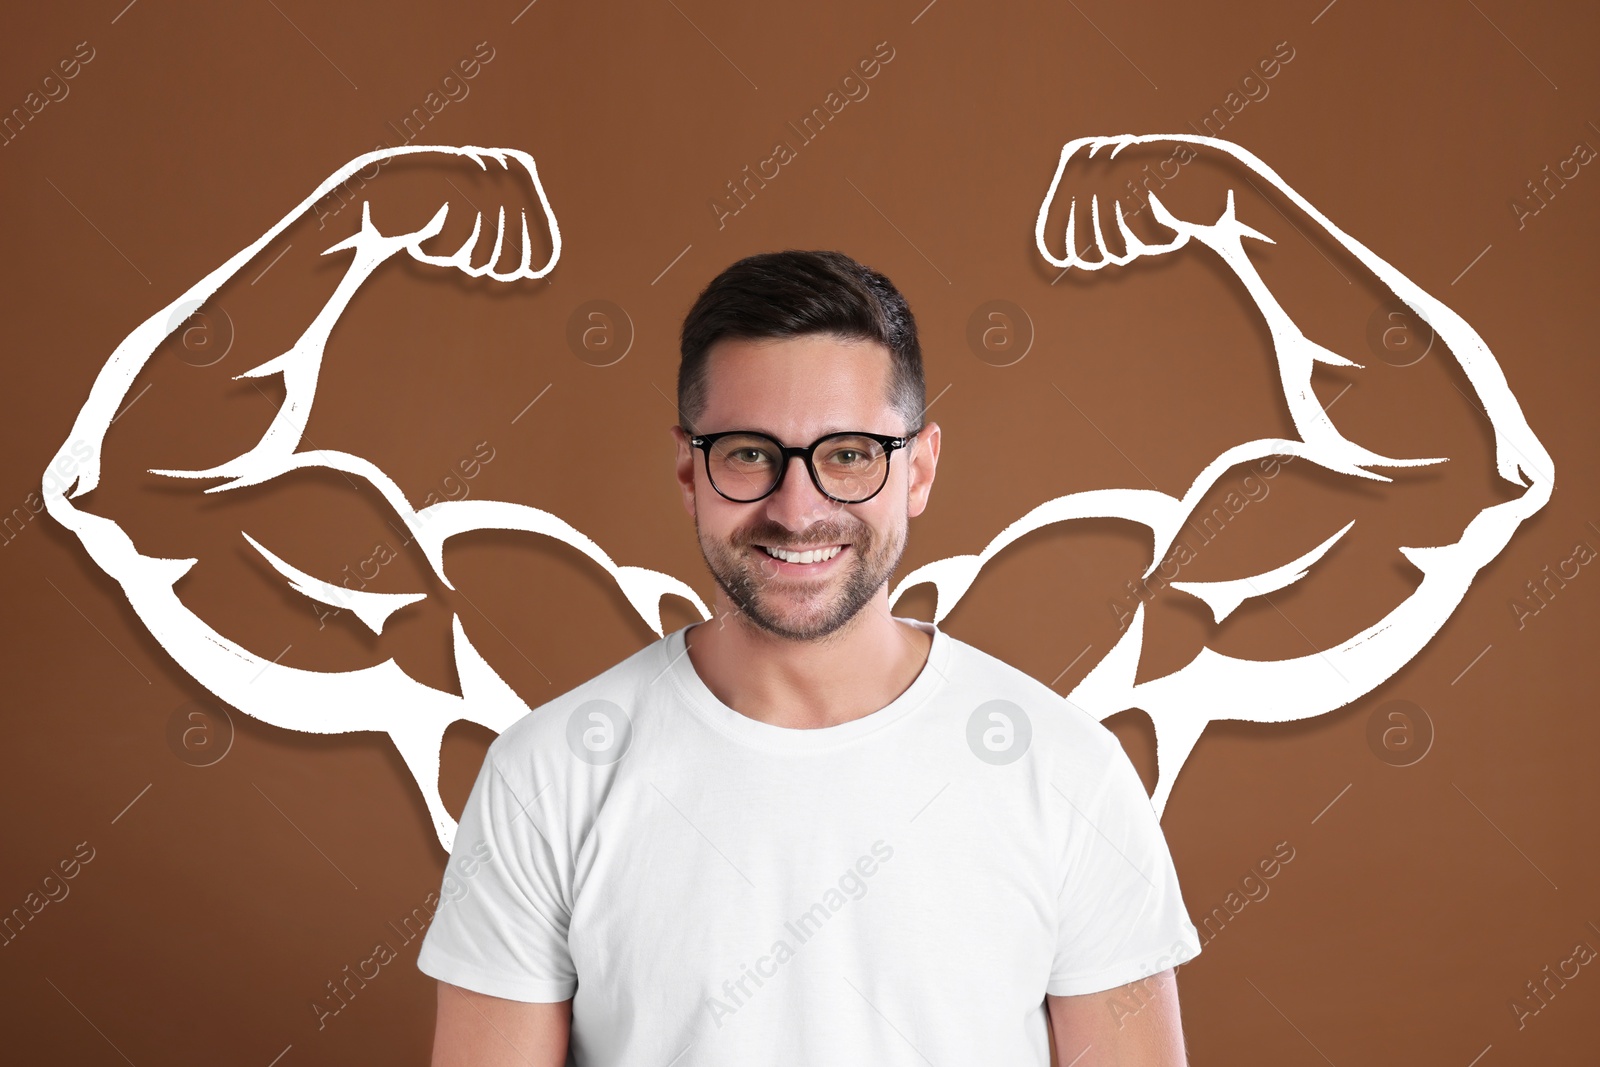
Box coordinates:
[45,149,707,851]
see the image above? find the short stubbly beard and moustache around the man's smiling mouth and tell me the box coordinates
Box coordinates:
[694,515,907,641]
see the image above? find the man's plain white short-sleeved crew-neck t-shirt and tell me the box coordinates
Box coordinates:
[418,619,1200,1067]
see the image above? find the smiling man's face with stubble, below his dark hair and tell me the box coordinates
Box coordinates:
[674,334,938,640]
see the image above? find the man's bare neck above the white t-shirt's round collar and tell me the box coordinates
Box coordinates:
[685,592,933,729]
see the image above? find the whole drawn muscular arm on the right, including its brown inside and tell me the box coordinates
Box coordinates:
[891,136,1554,813]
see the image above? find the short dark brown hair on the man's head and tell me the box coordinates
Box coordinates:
[678,248,928,434]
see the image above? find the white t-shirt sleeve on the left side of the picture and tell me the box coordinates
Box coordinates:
[416,747,578,1003]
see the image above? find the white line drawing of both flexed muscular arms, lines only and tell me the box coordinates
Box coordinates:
[43,134,1554,851]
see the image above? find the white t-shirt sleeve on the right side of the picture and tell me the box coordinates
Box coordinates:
[1045,737,1200,997]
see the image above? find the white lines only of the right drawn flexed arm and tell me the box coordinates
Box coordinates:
[890,134,1555,813]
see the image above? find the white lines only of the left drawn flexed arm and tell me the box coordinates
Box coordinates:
[45,146,710,851]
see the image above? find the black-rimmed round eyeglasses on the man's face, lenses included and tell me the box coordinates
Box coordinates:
[690,427,922,504]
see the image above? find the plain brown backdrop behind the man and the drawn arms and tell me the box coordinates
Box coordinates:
[0,0,1600,1067]
